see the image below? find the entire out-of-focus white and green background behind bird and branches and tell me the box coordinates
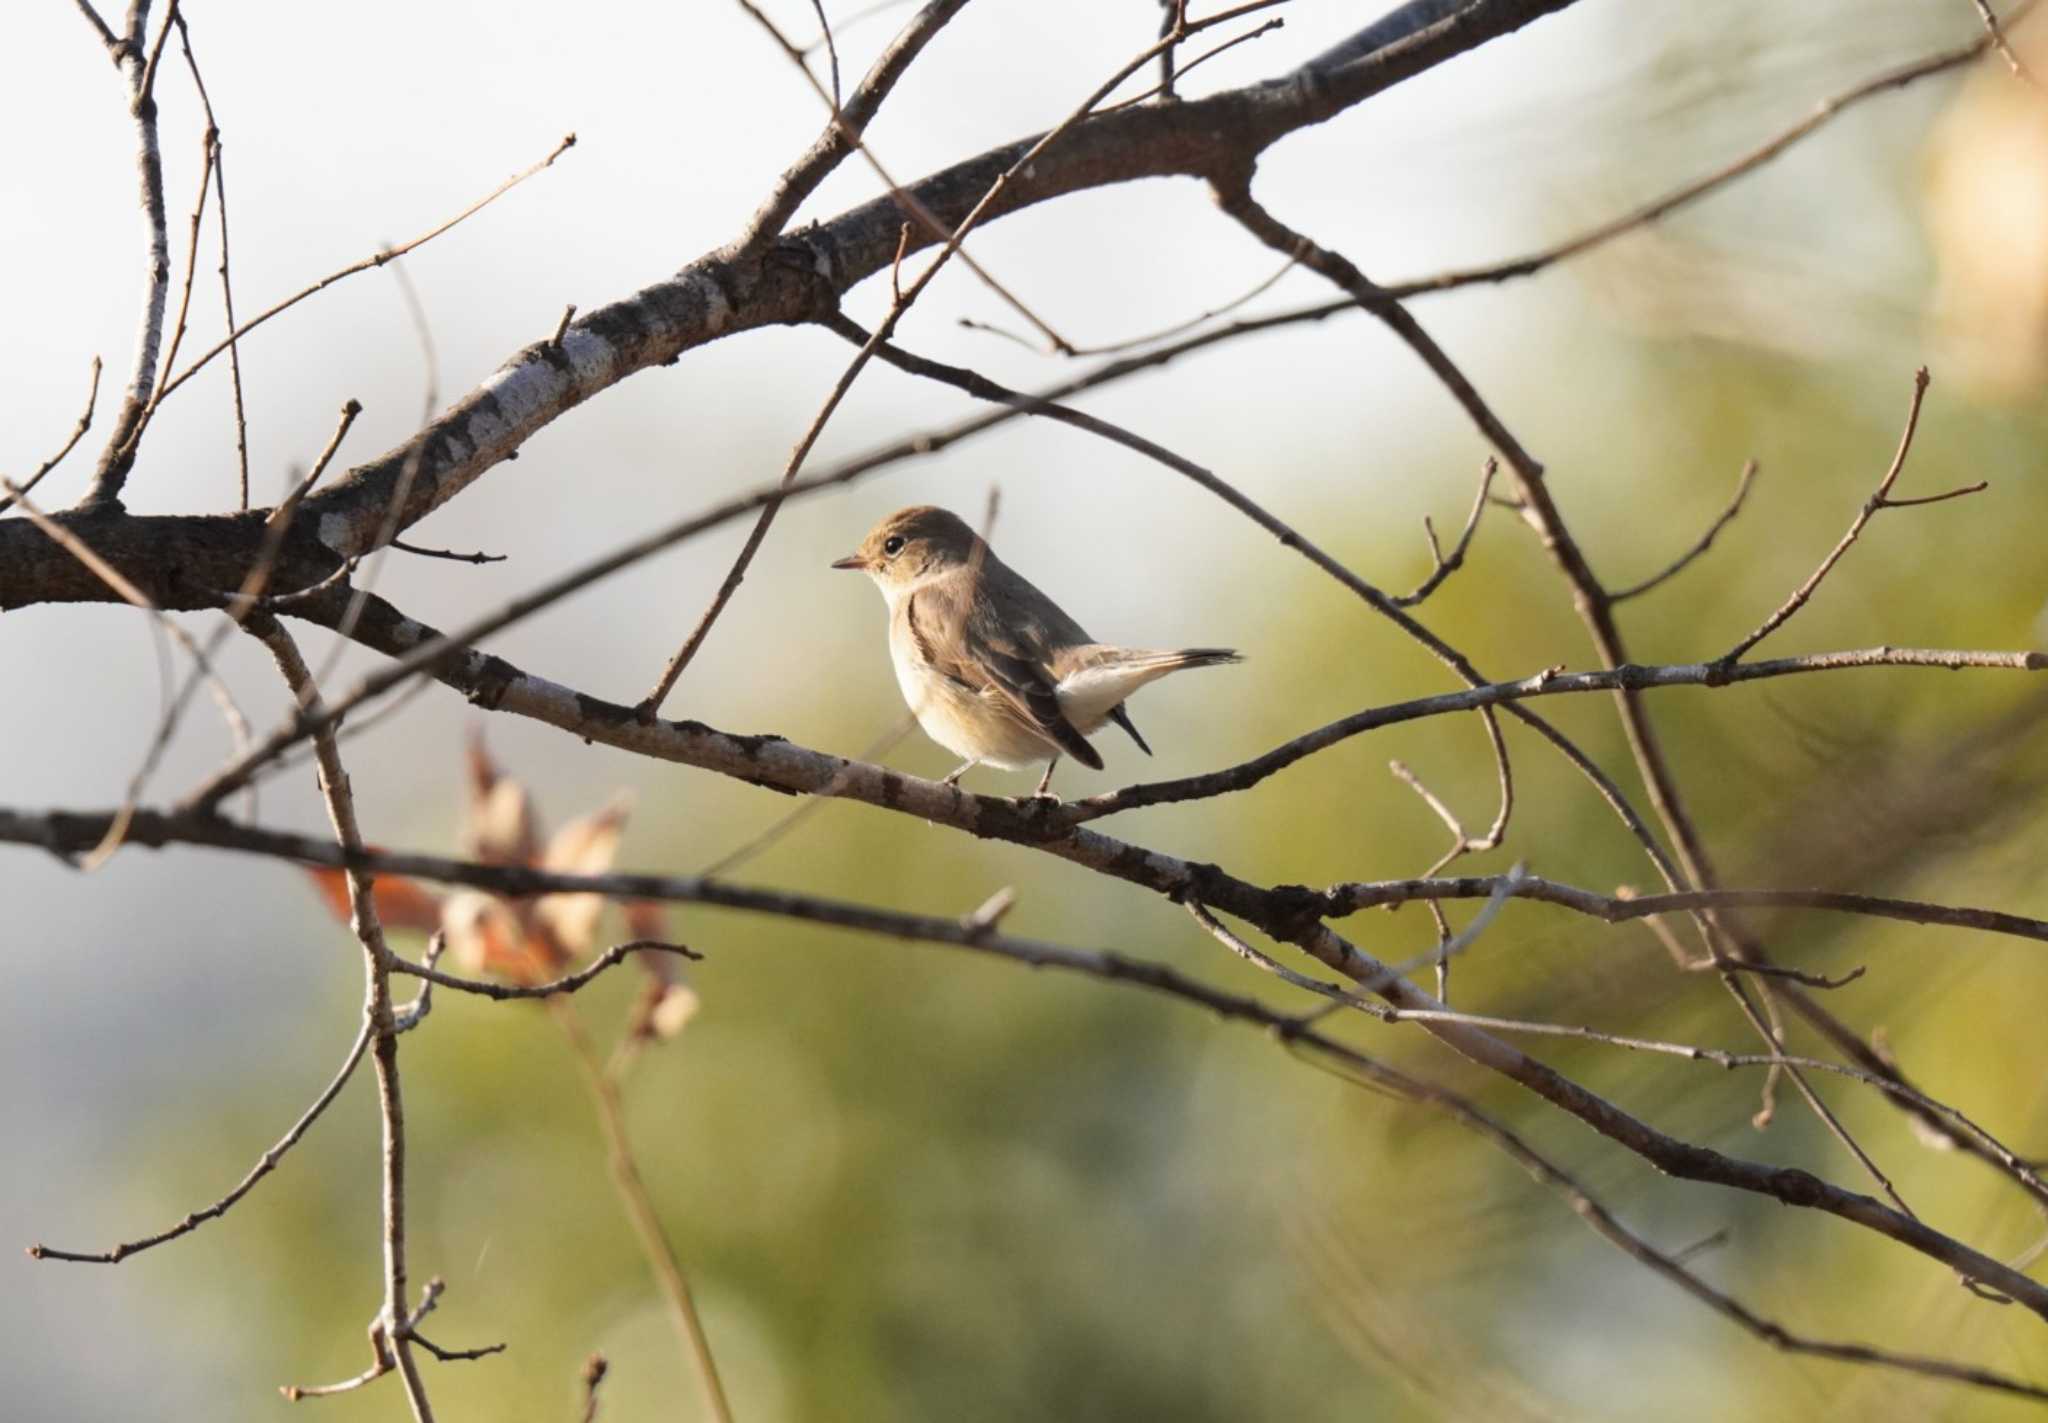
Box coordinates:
[0,0,2048,1423]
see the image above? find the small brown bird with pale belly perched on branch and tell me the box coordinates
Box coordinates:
[831,504,1243,801]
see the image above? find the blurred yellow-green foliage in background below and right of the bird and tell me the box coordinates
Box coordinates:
[108,327,2048,1421]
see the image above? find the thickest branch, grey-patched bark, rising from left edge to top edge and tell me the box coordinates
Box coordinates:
[0,0,1575,585]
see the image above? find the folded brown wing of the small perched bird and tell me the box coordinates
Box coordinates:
[905,577,1102,770]
